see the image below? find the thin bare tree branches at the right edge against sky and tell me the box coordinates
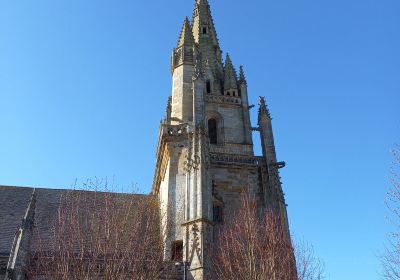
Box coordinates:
[381,145,400,280]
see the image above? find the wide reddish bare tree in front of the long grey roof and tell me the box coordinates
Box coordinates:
[29,179,164,280]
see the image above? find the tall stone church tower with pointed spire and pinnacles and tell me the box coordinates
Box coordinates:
[152,0,289,280]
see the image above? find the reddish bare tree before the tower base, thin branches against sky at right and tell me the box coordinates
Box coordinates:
[212,196,323,280]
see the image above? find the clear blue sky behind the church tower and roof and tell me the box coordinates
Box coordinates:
[0,0,400,280]
